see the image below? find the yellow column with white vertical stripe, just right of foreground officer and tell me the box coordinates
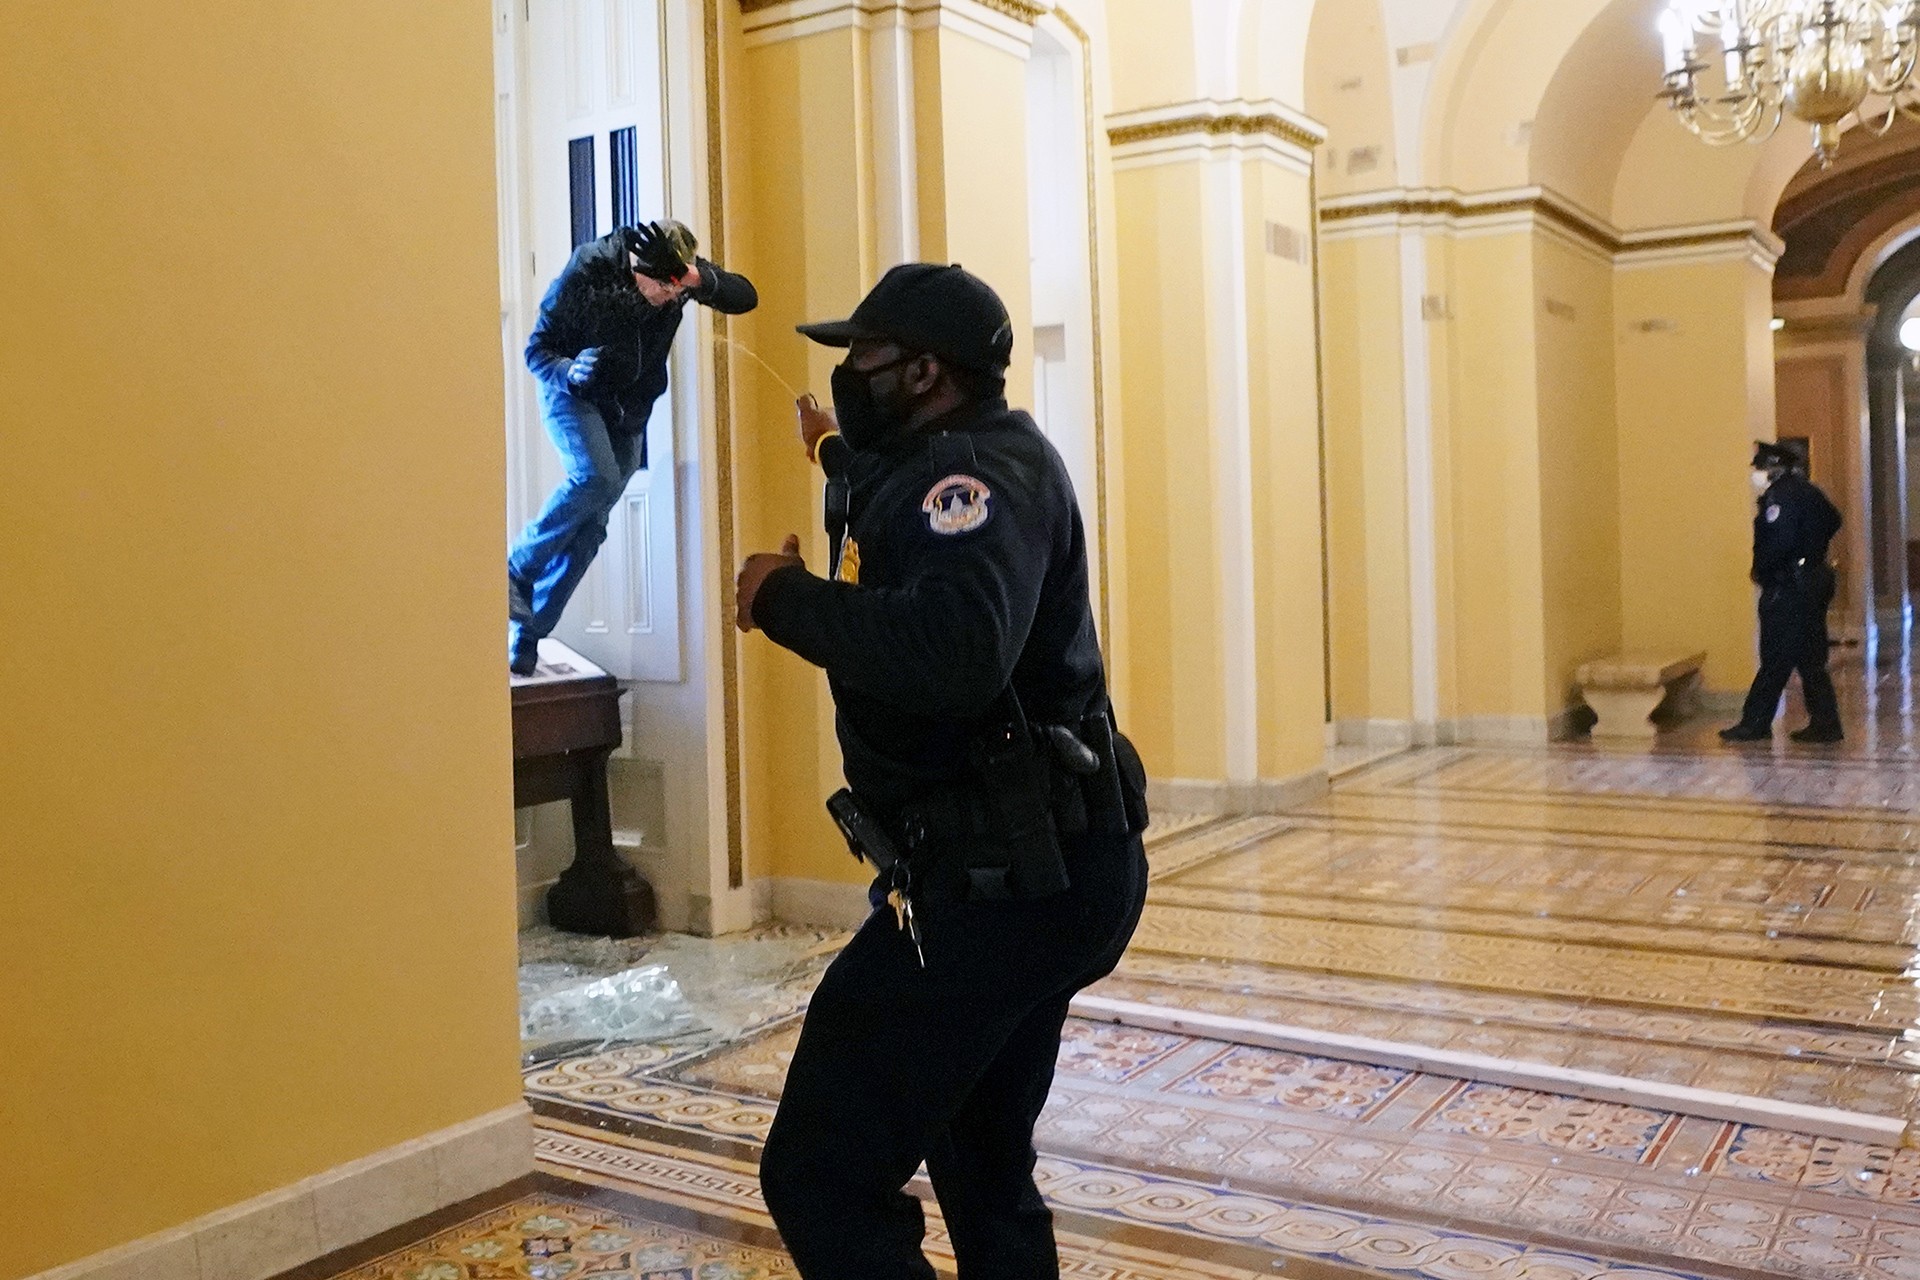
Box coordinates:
[1108,100,1325,808]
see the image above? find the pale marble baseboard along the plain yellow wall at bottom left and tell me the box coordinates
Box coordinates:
[29,1102,534,1280]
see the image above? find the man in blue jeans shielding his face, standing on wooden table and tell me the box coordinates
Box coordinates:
[507,223,760,676]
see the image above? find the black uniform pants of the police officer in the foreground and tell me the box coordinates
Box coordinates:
[760,837,1146,1280]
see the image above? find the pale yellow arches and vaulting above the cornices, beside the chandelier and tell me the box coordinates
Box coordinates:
[1106,0,1860,230]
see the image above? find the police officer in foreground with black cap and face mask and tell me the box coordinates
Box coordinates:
[737,263,1146,1280]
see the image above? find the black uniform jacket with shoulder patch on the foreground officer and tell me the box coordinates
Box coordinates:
[753,399,1106,821]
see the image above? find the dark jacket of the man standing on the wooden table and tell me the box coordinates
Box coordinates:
[526,230,760,450]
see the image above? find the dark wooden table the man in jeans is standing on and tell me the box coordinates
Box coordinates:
[513,639,657,938]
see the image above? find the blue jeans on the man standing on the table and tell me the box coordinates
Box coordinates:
[507,386,645,649]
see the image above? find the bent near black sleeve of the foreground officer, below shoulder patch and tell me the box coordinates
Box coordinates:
[753,476,1052,718]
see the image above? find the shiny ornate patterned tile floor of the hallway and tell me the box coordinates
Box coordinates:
[288,652,1920,1280]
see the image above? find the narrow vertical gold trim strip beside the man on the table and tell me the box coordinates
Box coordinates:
[701,0,749,889]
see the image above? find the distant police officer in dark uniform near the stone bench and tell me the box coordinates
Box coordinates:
[1720,443,1845,743]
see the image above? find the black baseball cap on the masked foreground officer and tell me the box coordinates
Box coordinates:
[799,263,1014,376]
